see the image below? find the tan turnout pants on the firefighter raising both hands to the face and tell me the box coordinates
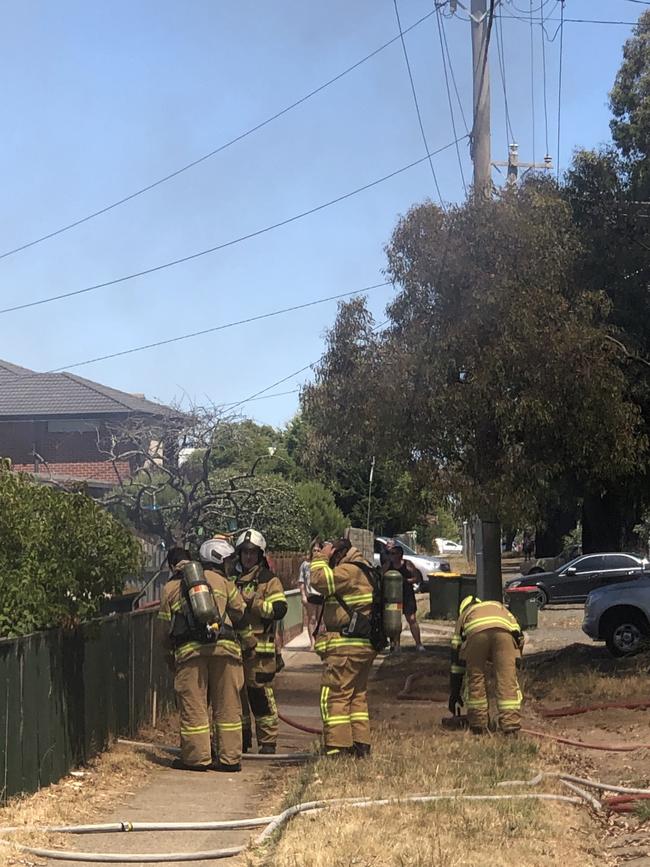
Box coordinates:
[320,649,376,752]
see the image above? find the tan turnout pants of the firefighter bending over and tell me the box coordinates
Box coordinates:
[462,629,522,731]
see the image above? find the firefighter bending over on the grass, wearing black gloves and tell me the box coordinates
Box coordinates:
[449,596,524,734]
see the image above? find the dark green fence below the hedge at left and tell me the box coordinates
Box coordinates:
[0,609,174,802]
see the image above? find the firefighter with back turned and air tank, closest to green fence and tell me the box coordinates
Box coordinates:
[158,539,255,771]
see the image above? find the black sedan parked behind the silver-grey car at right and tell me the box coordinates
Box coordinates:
[504,553,648,608]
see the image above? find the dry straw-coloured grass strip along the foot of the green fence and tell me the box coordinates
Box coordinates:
[0,744,157,867]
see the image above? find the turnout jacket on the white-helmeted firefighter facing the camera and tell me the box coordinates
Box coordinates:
[235,563,287,673]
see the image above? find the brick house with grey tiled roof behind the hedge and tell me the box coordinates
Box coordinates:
[0,359,173,489]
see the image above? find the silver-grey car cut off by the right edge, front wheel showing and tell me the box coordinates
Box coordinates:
[582,576,650,656]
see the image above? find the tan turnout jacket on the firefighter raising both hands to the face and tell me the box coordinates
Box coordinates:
[310,547,375,656]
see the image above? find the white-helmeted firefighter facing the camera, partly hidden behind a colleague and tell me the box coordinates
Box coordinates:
[235,530,287,754]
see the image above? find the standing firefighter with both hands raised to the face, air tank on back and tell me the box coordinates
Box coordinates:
[311,539,376,758]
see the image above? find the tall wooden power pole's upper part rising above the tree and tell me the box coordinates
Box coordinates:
[470,0,492,195]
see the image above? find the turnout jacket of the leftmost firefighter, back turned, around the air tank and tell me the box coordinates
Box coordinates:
[158,562,256,663]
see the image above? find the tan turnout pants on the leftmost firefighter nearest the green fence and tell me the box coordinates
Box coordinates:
[174,654,244,767]
